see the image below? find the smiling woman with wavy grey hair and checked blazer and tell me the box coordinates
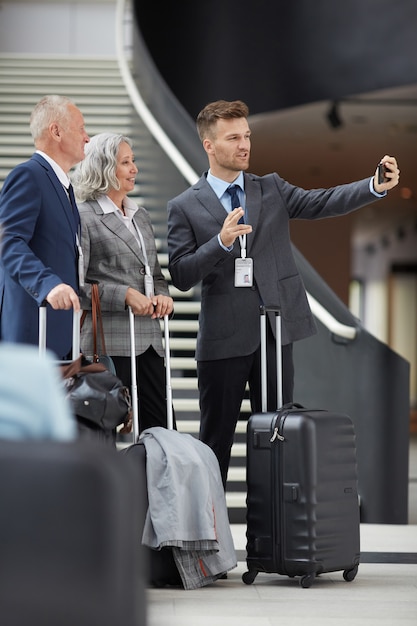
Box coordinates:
[73,133,173,431]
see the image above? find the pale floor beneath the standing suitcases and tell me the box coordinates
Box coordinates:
[147,437,417,626]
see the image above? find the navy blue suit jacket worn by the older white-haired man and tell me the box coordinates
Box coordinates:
[0,153,78,358]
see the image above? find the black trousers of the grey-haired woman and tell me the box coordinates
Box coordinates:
[112,346,175,432]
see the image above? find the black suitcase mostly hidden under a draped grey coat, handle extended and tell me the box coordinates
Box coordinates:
[123,307,182,587]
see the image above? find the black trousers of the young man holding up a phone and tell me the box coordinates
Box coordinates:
[197,324,294,486]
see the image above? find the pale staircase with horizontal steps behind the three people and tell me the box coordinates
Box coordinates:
[0,55,249,523]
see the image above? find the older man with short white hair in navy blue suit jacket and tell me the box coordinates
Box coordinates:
[0,95,89,359]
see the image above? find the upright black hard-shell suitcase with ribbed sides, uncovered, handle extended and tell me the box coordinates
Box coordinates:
[242,307,360,588]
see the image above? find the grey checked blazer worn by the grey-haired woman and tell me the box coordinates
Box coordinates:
[78,201,169,356]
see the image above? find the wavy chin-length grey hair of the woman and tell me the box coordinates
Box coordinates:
[71,133,132,202]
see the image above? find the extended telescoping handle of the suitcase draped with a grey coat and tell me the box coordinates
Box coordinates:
[129,307,174,443]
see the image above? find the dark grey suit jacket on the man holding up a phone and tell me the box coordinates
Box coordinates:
[168,173,377,360]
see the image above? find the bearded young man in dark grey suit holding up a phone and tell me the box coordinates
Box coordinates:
[168,100,399,485]
